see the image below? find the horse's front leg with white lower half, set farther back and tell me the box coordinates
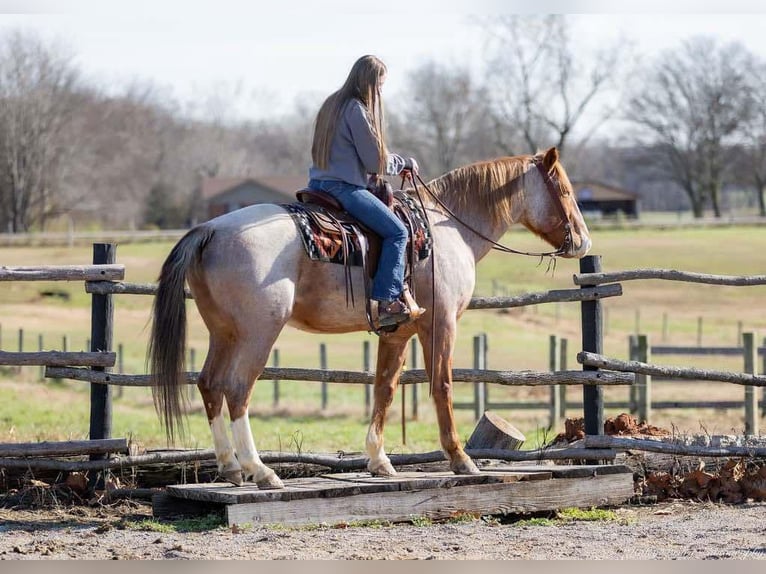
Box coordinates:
[365,336,408,476]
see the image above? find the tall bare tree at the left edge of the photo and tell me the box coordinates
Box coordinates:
[0,31,78,232]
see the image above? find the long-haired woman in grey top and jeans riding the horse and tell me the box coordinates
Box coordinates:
[309,56,424,327]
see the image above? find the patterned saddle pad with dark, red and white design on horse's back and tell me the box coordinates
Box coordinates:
[280,191,433,272]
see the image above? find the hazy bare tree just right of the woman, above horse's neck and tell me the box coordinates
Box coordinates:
[390,61,487,175]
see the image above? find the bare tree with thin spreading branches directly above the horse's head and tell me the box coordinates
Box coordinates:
[483,15,625,158]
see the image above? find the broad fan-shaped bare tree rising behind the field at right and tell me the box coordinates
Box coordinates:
[628,37,754,217]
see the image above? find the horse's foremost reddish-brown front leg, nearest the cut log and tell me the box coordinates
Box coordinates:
[418,321,479,474]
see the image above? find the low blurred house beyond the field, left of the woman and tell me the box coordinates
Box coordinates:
[207,175,308,219]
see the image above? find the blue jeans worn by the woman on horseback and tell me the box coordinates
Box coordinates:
[309,179,407,301]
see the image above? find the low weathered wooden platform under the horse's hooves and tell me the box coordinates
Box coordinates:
[153,465,633,525]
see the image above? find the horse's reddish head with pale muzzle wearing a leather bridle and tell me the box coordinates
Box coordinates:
[521,147,591,258]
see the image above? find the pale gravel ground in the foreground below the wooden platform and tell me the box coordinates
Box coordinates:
[0,501,766,560]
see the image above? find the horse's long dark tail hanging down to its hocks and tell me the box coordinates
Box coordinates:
[147,225,214,443]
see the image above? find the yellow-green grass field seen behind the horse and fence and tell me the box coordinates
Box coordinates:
[0,226,766,452]
